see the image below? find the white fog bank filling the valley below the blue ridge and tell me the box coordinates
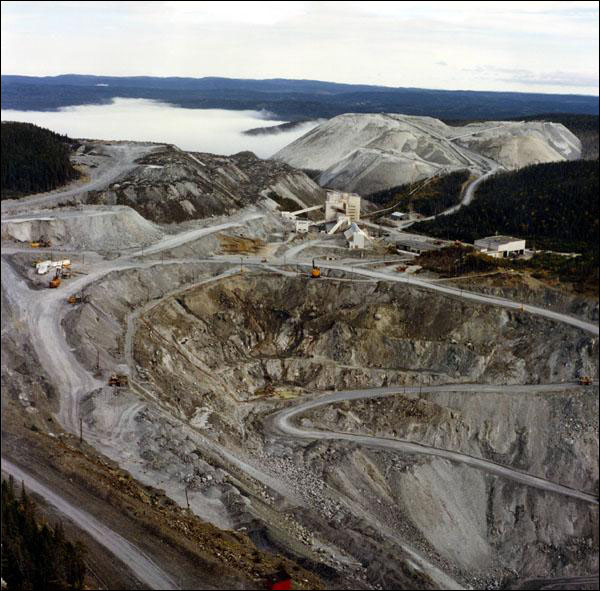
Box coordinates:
[1,98,319,158]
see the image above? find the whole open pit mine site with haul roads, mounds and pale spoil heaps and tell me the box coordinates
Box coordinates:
[1,134,598,589]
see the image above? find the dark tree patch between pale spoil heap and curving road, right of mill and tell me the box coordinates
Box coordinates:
[367,170,469,216]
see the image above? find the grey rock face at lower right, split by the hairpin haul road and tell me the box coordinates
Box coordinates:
[301,388,598,579]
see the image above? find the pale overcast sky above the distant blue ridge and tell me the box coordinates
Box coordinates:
[1,1,598,94]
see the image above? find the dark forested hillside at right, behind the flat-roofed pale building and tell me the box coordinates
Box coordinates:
[412,160,599,253]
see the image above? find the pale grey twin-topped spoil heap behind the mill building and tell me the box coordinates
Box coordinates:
[273,113,581,194]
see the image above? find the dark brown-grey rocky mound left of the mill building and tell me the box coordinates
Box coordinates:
[88,146,325,223]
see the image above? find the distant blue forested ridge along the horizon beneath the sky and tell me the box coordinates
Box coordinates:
[1,74,598,121]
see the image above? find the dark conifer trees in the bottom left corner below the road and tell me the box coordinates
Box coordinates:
[2,478,86,589]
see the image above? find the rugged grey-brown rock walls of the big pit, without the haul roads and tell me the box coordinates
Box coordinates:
[48,264,598,588]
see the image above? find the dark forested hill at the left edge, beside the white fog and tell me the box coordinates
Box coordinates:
[1,121,79,199]
